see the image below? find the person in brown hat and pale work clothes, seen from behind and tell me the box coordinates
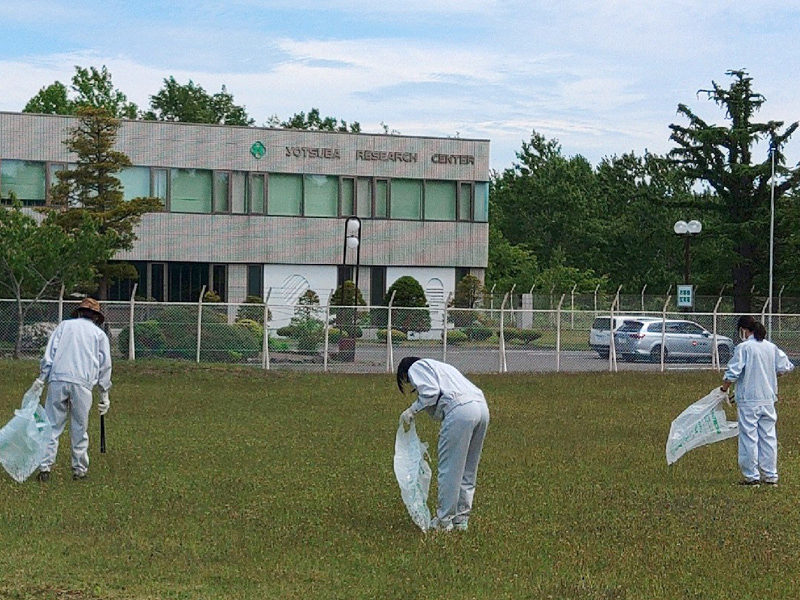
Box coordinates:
[34,298,111,481]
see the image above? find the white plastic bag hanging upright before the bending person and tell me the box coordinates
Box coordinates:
[394,420,431,531]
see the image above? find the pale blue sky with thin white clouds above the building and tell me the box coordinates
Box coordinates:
[0,0,800,172]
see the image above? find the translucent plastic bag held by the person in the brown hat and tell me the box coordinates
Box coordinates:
[0,387,52,483]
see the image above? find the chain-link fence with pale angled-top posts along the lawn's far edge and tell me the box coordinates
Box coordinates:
[0,298,800,373]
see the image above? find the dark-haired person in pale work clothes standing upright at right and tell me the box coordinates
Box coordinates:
[720,316,794,485]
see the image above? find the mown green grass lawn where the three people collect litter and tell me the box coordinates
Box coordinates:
[0,362,800,600]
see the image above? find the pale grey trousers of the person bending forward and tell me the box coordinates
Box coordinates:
[436,400,489,527]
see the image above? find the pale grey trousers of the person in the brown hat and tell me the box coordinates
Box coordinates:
[39,381,92,475]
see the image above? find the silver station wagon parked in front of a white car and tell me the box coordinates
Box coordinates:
[614,319,733,365]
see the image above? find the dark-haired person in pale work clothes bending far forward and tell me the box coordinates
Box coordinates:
[397,356,489,531]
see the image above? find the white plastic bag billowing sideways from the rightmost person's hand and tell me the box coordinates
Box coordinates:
[667,388,739,465]
